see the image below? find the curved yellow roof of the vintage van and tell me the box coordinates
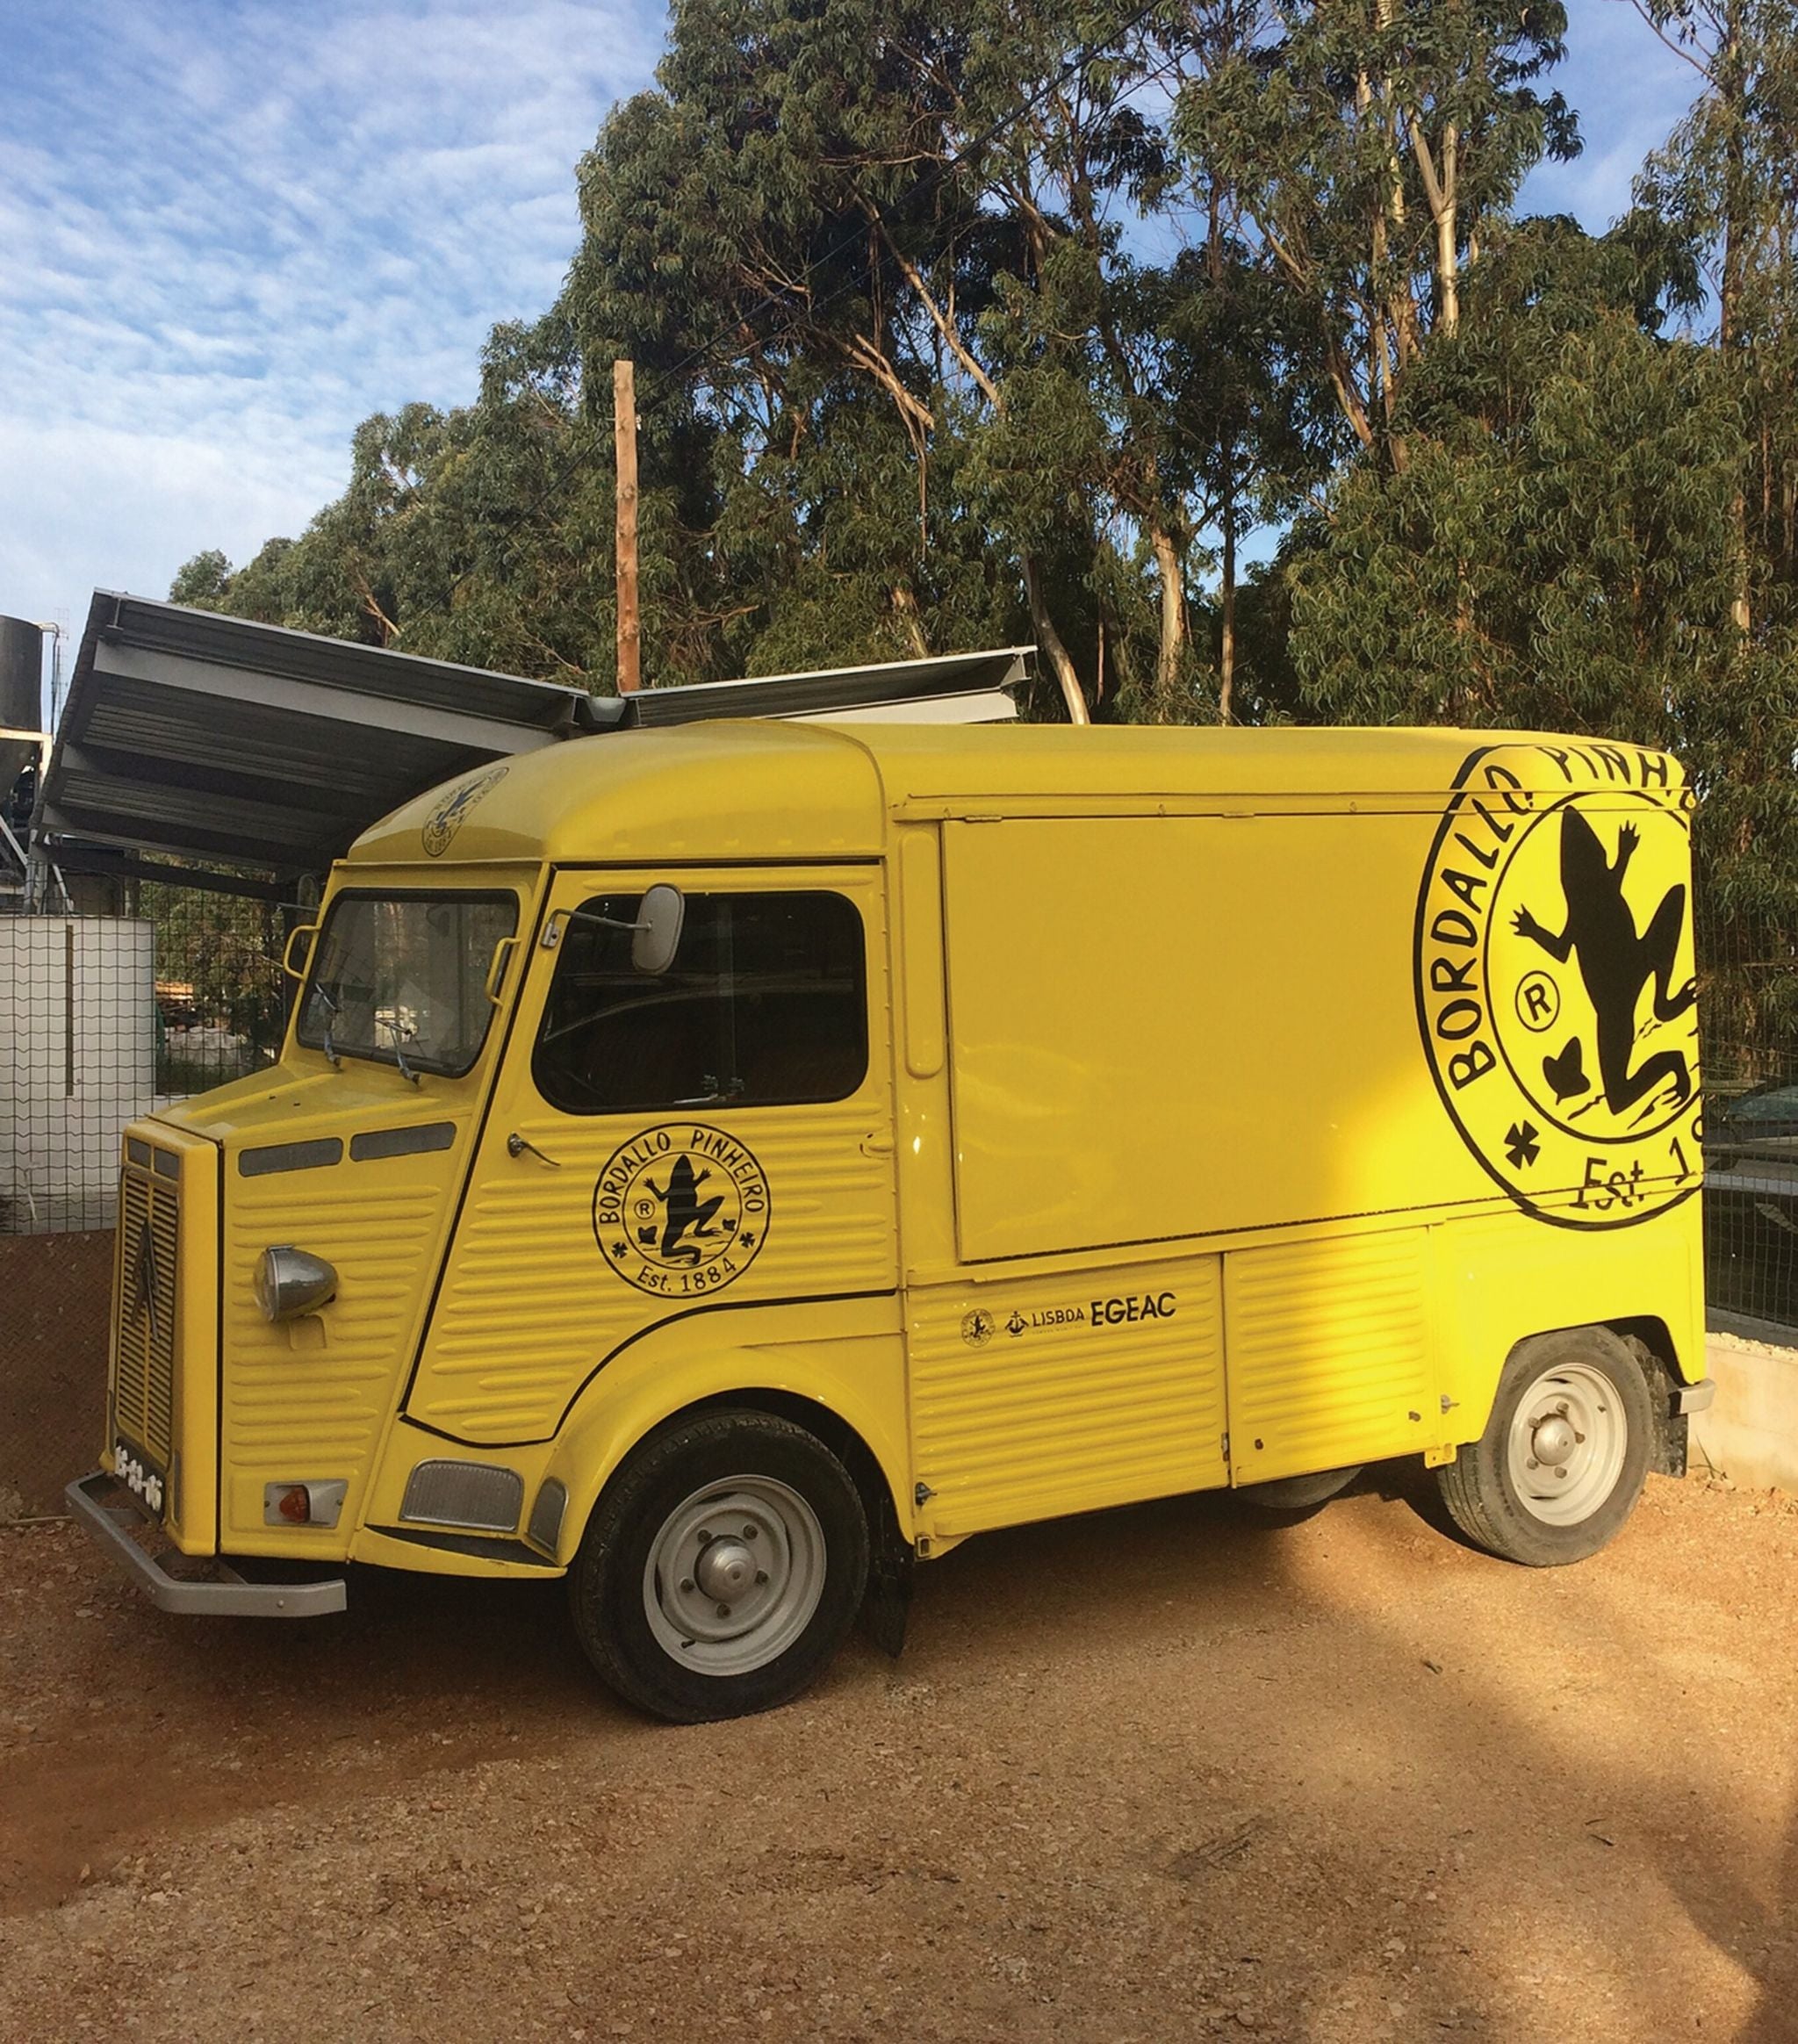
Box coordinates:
[349,717,1681,865]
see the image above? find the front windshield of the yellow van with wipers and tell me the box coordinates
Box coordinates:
[296,893,519,1077]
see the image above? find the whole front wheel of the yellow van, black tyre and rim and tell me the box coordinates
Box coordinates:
[568,1408,868,1725]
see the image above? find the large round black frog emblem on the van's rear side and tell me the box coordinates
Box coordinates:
[1416,744,1700,1228]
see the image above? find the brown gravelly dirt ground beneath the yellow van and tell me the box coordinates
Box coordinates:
[0,1478,1798,2044]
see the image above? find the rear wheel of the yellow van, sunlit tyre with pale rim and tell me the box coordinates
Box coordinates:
[1436,1327,1655,1568]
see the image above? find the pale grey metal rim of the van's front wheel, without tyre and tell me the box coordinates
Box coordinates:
[644,1476,825,1676]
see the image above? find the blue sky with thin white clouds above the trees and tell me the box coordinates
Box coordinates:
[0,0,1694,670]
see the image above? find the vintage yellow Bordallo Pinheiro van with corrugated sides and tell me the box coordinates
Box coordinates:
[71,719,1708,1719]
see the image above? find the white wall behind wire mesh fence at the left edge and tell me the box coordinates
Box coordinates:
[0,916,155,1234]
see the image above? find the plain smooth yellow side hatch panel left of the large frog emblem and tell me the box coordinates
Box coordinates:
[944,811,1492,1261]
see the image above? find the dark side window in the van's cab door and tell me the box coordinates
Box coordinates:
[531,893,868,1114]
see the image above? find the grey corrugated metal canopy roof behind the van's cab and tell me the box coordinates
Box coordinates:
[37,591,1032,891]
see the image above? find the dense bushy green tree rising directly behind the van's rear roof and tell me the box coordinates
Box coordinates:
[1290,220,1741,748]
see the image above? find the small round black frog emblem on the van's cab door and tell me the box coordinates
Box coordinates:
[593,1122,768,1298]
